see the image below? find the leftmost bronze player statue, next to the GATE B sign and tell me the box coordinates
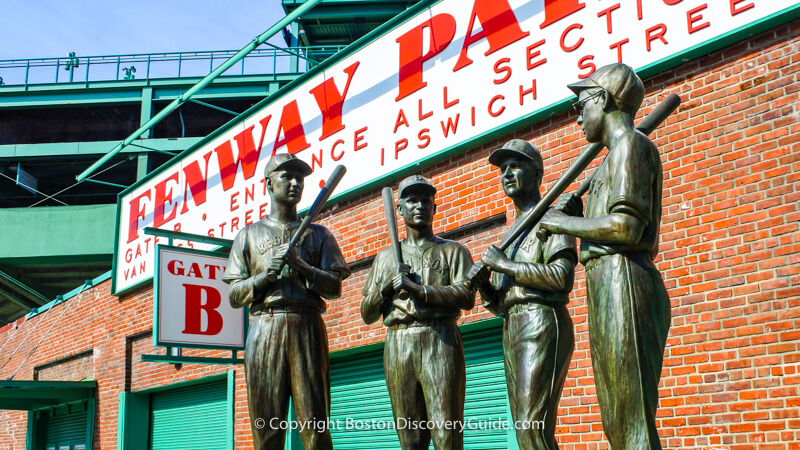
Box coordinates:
[223,154,350,450]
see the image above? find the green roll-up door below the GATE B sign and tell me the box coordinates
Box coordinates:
[150,380,228,450]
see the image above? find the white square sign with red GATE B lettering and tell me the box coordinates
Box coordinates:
[153,245,247,349]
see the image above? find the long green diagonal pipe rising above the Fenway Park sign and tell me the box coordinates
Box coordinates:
[75,0,322,181]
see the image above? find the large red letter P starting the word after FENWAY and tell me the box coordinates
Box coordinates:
[395,14,456,100]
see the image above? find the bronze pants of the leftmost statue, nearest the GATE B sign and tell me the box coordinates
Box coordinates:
[244,313,333,450]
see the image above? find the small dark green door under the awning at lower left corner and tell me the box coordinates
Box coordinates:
[37,403,86,450]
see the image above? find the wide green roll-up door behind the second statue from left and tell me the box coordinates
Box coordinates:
[331,327,515,450]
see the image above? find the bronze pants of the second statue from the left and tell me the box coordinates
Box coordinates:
[383,323,466,450]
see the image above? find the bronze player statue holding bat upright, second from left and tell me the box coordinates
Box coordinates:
[361,175,475,450]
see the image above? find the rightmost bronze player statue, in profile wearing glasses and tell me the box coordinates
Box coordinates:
[541,64,670,450]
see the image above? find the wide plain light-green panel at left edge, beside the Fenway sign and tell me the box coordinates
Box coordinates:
[0,205,116,260]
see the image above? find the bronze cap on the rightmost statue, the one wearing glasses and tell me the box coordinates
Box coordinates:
[567,63,644,114]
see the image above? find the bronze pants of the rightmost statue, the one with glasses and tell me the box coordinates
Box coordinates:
[586,254,670,450]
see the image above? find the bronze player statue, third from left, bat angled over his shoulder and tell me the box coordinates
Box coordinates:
[470,139,580,450]
